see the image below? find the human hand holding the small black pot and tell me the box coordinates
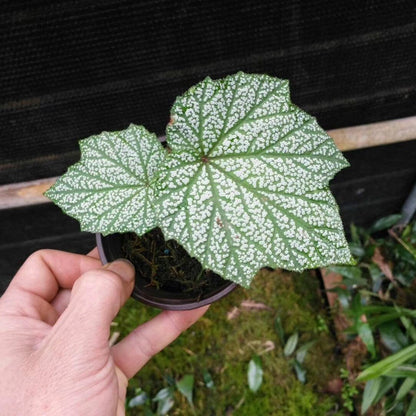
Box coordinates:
[0,250,207,416]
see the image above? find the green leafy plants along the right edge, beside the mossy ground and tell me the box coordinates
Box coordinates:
[332,215,416,416]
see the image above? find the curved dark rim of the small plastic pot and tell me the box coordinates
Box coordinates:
[95,233,239,311]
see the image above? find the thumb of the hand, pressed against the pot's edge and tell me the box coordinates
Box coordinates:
[56,259,135,343]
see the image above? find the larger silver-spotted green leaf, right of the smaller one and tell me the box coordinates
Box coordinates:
[156,72,351,286]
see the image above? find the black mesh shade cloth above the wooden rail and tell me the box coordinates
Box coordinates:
[0,0,416,184]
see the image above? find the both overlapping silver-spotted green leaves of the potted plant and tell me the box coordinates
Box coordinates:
[47,72,351,286]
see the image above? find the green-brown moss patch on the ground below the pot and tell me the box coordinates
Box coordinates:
[115,270,342,416]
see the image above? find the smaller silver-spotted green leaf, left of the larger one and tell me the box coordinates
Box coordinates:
[46,124,166,235]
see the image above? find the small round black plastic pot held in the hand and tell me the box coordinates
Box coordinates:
[96,234,238,311]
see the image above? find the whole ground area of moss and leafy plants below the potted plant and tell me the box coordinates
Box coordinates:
[109,216,416,416]
